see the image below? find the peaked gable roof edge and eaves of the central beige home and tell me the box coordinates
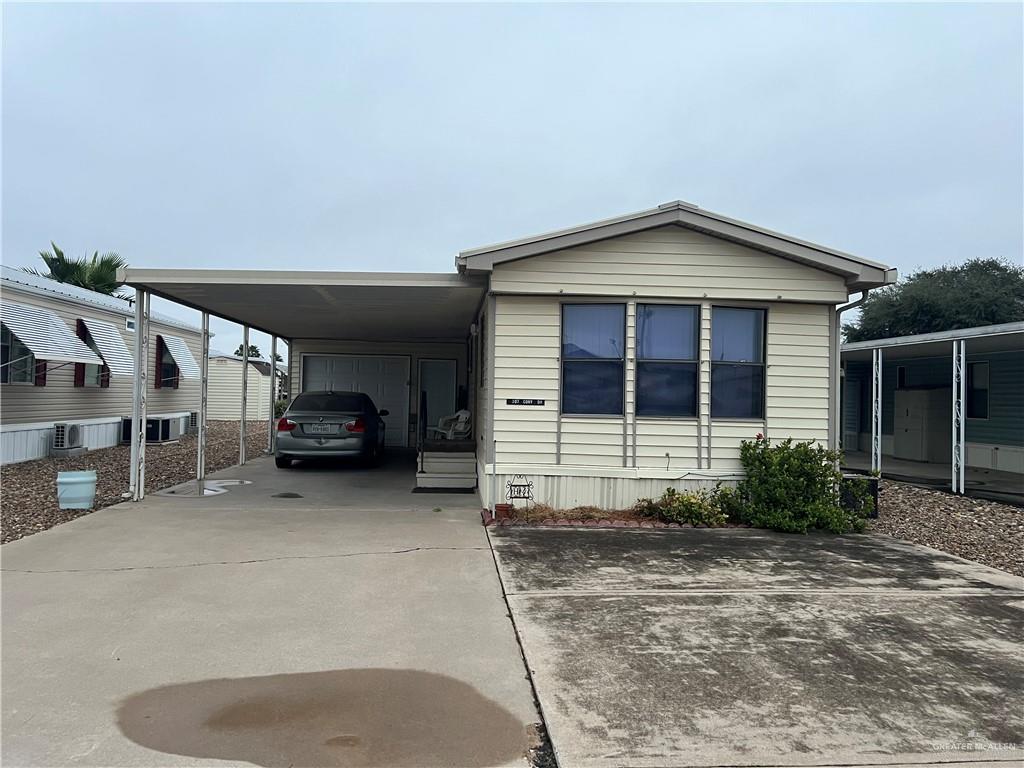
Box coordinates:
[457,200,896,291]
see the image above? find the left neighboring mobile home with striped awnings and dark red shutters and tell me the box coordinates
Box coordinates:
[0,266,202,464]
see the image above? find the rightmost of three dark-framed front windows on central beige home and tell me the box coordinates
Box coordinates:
[711,307,765,419]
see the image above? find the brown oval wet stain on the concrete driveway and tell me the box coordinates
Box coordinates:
[118,669,529,768]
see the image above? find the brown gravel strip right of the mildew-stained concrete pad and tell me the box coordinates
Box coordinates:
[868,480,1024,577]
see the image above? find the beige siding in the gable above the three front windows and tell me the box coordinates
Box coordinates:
[490,226,848,303]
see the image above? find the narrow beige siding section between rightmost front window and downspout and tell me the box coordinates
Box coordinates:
[765,304,834,444]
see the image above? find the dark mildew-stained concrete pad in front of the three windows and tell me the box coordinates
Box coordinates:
[490,528,1024,768]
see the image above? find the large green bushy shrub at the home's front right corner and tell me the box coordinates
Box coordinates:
[737,434,865,534]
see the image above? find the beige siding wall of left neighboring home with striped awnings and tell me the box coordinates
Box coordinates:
[2,287,202,427]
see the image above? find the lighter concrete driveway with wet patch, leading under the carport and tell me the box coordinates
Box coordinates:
[0,458,539,766]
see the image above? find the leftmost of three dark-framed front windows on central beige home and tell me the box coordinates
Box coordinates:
[561,304,626,416]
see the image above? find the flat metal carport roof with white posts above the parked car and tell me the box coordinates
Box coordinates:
[118,268,486,501]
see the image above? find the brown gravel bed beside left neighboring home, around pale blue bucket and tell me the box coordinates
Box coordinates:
[0,421,266,544]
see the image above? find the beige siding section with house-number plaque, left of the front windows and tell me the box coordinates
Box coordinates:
[493,296,557,464]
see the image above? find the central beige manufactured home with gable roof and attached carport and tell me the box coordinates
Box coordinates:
[119,202,896,507]
